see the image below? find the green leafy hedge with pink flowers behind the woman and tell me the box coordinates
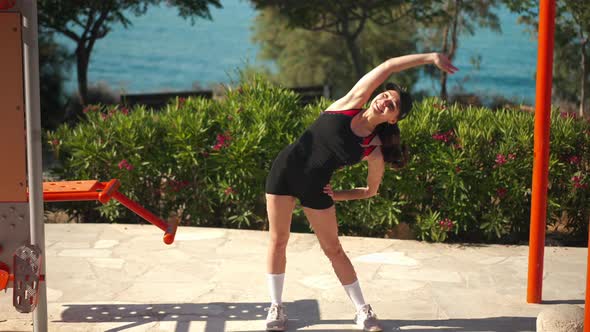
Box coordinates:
[46,79,590,242]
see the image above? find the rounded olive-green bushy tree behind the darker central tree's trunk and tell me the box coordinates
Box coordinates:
[253,8,418,96]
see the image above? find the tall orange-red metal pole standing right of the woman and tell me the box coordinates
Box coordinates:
[527,0,555,303]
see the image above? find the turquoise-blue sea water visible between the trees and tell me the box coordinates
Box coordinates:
[59,0,536,103]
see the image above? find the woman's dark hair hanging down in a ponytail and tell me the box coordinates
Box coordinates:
[375,83,413,168]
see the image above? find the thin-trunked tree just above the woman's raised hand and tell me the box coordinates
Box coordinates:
[424,0,501,100]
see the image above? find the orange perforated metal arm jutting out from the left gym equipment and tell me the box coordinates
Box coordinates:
[38,179,178,244]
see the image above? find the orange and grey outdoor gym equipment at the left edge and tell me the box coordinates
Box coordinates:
[0,0,178,331]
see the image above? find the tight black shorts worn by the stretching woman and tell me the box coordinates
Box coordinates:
[265,146,334,210]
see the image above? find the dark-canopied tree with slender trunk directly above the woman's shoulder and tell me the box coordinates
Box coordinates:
[251,0,438,79]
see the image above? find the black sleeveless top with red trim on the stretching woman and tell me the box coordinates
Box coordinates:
[290,109,375,176]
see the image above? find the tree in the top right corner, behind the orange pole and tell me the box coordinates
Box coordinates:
[504,0,590,116]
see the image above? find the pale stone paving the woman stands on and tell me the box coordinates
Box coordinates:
[0,224,587,332]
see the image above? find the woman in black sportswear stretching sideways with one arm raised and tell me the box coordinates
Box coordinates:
[266,53,458,331]
